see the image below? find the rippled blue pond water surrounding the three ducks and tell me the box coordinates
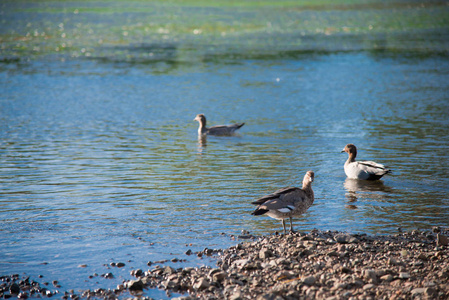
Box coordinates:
[0,1,449,298]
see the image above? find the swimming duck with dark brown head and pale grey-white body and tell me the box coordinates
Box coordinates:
[341,144,391,180]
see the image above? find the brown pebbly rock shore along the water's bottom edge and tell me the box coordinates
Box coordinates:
[0,228,449,300]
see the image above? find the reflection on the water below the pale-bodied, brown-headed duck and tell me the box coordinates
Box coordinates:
[343,178,392,209]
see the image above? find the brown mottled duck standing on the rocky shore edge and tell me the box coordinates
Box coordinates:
[251,171,315,234]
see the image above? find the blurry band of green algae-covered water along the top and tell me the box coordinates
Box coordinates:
[0,0,449,62]
